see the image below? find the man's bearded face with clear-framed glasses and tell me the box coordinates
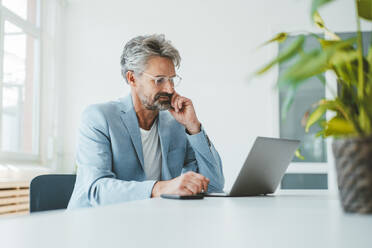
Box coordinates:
[135,56,176,110]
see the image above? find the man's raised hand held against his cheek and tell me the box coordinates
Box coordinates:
[169,92,200,134]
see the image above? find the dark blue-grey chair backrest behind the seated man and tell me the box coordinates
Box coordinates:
[30,174,76,213]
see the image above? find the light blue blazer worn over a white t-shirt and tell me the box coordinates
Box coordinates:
[68,95,224,209]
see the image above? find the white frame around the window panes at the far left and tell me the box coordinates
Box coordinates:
[0,0,42,163]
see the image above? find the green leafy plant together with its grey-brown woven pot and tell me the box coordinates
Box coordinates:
[256,0,372,213]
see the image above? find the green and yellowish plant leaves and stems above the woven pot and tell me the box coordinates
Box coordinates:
[256,0,372,137]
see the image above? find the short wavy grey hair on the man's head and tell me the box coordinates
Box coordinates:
[120,34,181,83]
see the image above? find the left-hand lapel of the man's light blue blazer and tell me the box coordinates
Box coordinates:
[120,95,144,168]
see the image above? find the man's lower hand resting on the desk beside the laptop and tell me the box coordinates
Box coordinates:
[151,171,209,197]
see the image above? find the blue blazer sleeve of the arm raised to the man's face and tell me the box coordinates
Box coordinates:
[182,126,225,192]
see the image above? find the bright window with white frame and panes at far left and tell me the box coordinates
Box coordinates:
[0,0,40,160]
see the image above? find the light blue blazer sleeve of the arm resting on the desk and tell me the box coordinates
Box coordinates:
[74,105,156,206]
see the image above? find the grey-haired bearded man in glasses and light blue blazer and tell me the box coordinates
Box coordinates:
[68,35,224,209]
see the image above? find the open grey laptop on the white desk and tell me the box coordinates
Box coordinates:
[204,137,300,197]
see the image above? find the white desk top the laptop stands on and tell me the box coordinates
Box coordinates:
[0,191,372,248]
